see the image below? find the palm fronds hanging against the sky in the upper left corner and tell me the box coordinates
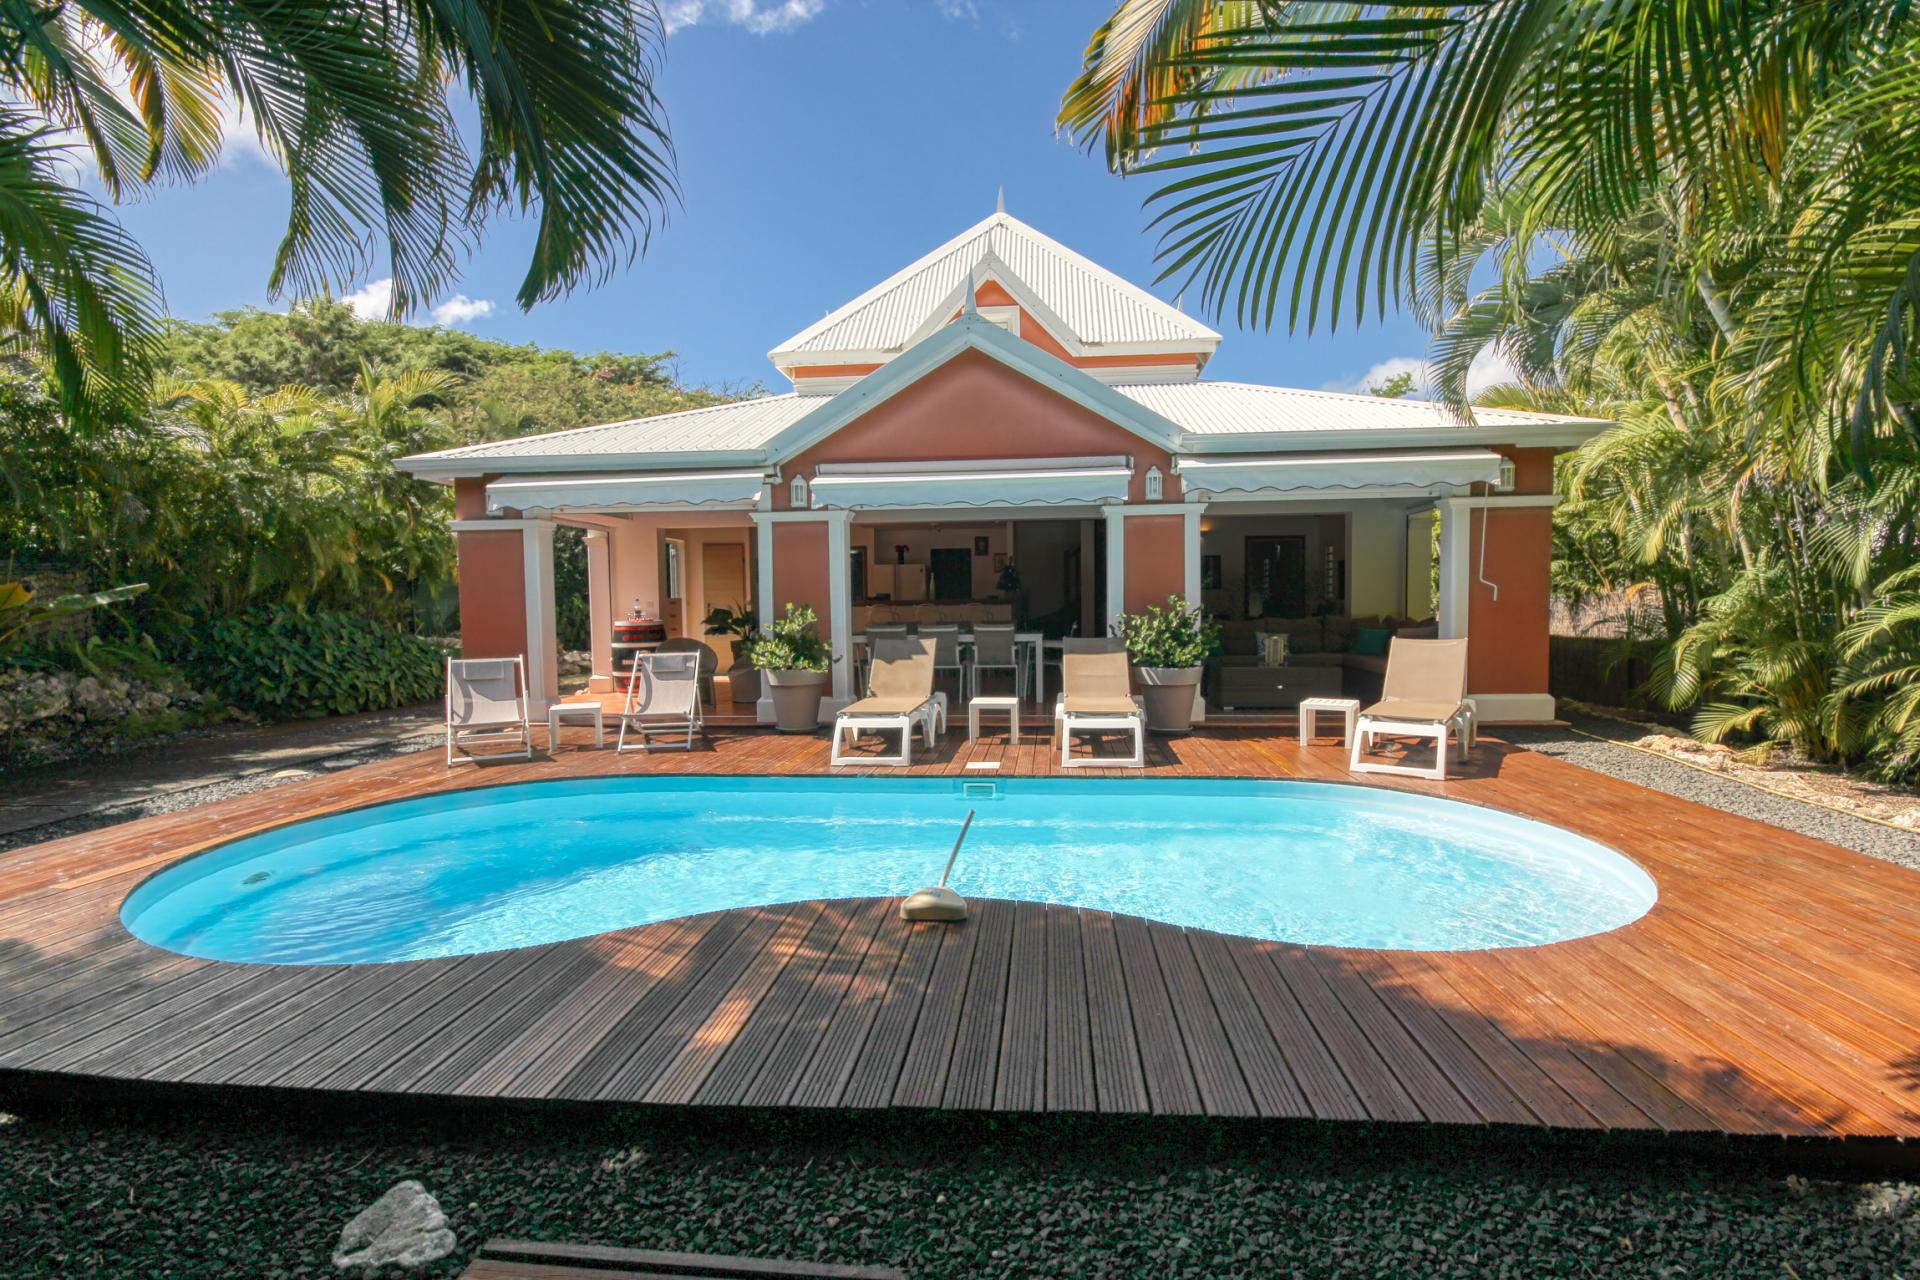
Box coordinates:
[0,0,676,415]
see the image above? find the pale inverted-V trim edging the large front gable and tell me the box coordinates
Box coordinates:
[766,315,1181,461]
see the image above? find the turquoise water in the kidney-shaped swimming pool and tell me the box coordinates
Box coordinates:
[121,777,1655,963]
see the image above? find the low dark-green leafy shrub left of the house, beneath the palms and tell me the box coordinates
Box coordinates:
[179,608,447,718]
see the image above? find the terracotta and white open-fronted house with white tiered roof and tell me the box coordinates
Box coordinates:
[401,211,1605,722]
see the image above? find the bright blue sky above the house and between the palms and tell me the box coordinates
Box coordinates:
[108,0,1466,390]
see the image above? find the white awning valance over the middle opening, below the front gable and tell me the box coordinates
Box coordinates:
[812,457,1133,510]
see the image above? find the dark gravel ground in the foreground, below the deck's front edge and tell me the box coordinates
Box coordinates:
[0,1094,1920,1280]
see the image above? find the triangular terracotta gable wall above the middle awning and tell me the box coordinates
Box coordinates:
[774,351,1181,509]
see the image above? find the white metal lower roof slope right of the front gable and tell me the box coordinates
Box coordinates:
[1114,382,1599,439]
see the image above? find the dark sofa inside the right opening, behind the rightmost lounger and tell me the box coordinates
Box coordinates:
[1204,616,1438,710]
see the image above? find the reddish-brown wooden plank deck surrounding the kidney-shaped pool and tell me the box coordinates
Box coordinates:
[0,725,1920,1138]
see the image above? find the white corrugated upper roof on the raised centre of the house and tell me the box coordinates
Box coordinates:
[768,213,1219,368]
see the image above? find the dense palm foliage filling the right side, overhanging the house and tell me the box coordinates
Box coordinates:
[1060,0,1920,775]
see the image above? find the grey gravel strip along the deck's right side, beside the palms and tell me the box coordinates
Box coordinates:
[1494,716,1920,871]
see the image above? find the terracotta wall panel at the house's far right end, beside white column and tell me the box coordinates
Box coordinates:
[1467,507,1553,693]
